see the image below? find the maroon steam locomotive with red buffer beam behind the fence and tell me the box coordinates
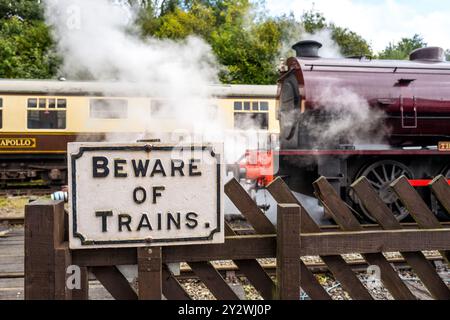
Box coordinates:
[246,41,450,221]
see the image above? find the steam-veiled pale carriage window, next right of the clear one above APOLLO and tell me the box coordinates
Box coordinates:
[89,99,128,119]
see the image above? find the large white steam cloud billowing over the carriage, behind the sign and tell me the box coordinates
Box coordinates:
[44,0,272,163]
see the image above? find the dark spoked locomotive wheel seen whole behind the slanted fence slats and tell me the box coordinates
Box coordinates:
[351,160,413,222]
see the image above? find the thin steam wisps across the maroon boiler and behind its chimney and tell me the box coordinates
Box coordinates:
[282,28,389,148]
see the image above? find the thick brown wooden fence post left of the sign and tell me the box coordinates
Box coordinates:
[25,200,67,300]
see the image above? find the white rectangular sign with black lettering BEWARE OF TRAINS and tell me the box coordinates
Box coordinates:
[68,143,224,249]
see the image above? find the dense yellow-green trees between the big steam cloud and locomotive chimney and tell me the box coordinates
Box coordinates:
[138,0,281,84]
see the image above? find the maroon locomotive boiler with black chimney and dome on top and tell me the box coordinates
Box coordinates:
[279,41,450,149]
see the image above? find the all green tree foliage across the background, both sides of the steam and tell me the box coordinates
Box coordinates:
[0,0,442,84]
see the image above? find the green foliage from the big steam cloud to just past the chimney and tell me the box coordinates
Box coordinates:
[139,0,372,84]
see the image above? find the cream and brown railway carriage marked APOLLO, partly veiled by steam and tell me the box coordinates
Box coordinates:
[0,80,279,187]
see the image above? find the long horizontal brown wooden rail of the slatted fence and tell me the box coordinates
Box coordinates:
[72,229,450,266]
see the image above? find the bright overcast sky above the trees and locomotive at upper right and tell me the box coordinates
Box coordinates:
[266,0,450,51]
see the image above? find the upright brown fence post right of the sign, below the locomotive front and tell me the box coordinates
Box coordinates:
[276,204,301,300]
